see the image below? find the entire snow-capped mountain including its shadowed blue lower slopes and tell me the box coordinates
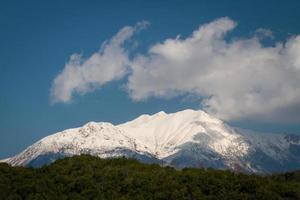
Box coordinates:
[3,110,300,173]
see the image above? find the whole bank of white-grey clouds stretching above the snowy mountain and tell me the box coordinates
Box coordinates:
[51,17,300,122]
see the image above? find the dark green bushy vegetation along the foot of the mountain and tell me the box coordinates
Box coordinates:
[0,155,300,200]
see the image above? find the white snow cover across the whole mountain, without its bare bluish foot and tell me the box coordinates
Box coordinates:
[4,109,298,171]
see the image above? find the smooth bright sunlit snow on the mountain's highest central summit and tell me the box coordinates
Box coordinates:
[118,110,246,158]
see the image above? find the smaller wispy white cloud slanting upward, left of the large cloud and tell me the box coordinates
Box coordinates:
[51,22,148,103]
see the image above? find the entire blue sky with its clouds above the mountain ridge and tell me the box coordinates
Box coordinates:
[0,0,300,158]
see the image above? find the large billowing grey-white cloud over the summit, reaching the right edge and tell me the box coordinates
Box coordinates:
[128,18,300,122]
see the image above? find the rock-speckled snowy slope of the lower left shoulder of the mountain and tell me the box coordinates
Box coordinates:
[7,122,155,165]
